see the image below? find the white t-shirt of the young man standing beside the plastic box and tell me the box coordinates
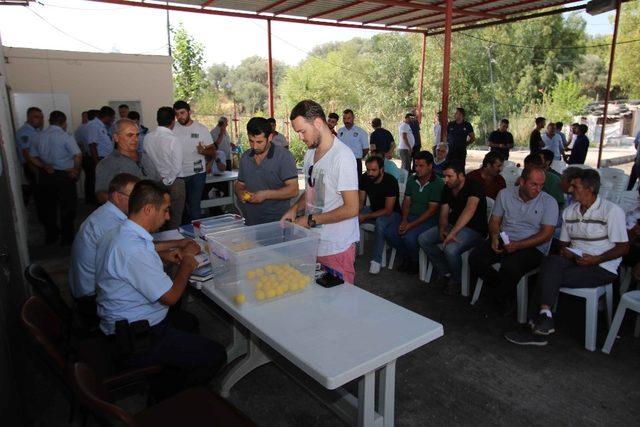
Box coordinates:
[304,138,360,256]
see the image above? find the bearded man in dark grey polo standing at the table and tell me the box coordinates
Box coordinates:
[235,117,298,225]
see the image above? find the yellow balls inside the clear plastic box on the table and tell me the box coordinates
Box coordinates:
[234,264,309,305]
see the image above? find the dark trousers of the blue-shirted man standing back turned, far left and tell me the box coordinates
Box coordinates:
[38,169,78,244]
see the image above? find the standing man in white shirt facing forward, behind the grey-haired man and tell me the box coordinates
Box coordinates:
[173,101,213,222]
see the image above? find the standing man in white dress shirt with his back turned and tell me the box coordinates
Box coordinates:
[144,107,185,230]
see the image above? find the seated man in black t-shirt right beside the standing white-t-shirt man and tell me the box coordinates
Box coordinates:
[358,156,400,274]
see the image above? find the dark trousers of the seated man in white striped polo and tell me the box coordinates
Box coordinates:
[536,255,618,307]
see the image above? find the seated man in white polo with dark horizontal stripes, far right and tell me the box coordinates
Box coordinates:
[505,169,629,345]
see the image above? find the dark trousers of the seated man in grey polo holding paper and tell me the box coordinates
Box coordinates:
[469,239,543,301]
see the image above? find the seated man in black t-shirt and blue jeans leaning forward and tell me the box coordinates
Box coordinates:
[418,161,488,295]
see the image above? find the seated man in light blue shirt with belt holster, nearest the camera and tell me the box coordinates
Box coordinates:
[96,180,226,398]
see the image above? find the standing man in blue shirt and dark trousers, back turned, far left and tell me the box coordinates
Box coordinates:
[29,111,82,245]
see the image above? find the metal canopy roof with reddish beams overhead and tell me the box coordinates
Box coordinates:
[91,0,584,33]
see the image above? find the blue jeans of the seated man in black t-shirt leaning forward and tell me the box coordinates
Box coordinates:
[418,226,484,283]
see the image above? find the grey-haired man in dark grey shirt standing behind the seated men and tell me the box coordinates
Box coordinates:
[95,119,160,204]
